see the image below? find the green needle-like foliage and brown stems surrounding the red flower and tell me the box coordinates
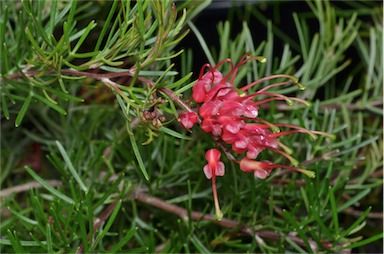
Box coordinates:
[0,0,383,253]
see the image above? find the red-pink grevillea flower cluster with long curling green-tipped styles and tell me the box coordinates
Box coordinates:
[178,54,332,218]
